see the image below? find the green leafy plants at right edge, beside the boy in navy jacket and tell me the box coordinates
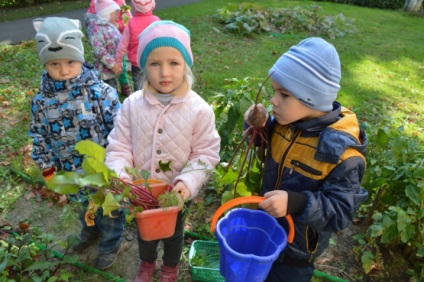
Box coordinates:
[359,120,424,280]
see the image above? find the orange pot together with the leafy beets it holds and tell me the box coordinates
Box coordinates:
[47,140,184,240]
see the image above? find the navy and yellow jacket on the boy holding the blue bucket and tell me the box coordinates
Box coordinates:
[261,102,368,265]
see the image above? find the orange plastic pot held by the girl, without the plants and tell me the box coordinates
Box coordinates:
[134,179,182,241]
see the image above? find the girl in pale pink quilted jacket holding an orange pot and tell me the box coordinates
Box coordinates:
[106,21,220,282]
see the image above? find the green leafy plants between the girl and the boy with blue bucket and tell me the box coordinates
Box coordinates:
[213,77,269,203]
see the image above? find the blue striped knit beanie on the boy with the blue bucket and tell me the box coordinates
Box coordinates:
[268,37,341,112]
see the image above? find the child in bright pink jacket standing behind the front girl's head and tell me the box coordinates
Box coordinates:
[115,0,160,91]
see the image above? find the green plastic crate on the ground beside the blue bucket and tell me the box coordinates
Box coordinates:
[188,240,225,282]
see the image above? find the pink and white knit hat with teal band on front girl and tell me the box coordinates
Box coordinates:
[137,21,193,69]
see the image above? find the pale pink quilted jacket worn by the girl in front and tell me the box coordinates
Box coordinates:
[106,90,220,197]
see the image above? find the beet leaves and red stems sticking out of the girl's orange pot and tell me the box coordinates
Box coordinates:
[47,140,181,225]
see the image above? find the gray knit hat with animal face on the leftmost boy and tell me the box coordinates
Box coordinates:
[33,17,85,66]
